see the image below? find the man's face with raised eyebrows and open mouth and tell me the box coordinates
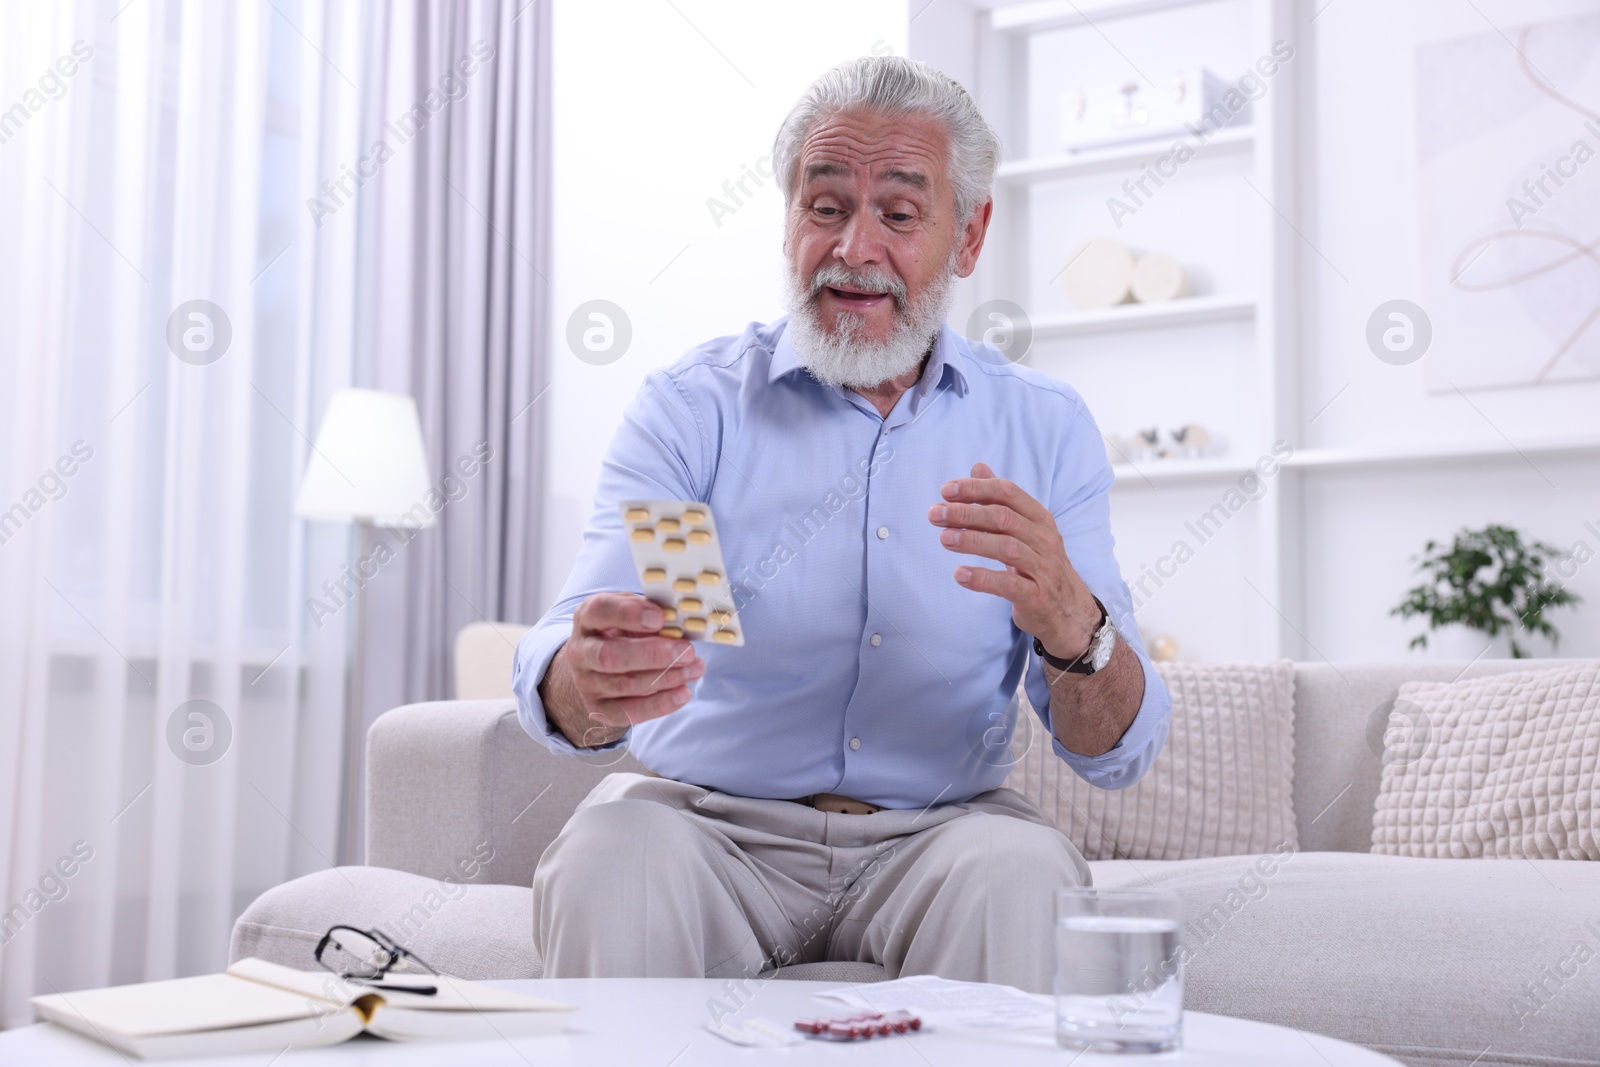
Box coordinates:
[786,112,989,344]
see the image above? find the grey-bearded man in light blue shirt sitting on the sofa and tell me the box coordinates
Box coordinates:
[515,58,1171,990]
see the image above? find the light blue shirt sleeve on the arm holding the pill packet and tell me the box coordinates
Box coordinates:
[512,371,707,753]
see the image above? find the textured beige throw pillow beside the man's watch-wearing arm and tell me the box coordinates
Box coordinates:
[1006,659,1298,859]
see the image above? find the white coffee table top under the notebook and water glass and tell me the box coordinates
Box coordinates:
[0,977,1398,1067]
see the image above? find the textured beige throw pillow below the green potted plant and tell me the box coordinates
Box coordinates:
[1373,662,1600,859]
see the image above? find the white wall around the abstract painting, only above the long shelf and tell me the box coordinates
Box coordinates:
[1301,0,1600,454]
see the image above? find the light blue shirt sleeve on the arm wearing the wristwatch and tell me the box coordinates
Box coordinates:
[1024,400,1173,789]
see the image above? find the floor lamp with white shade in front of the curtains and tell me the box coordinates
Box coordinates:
[294,389,434,864]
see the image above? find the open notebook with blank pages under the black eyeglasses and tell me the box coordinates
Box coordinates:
[30,958,576,1059]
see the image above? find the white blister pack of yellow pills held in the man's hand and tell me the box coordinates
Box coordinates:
[618,501,744,645]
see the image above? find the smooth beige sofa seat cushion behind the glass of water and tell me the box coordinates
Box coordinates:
[1094,849,1600,1067]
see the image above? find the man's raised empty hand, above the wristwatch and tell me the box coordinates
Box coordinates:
[928,464,1099,659]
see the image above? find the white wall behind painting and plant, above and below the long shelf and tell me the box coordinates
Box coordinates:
[1301,0,1600,659]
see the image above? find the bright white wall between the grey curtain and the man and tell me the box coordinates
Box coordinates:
[539,0,907,605]
